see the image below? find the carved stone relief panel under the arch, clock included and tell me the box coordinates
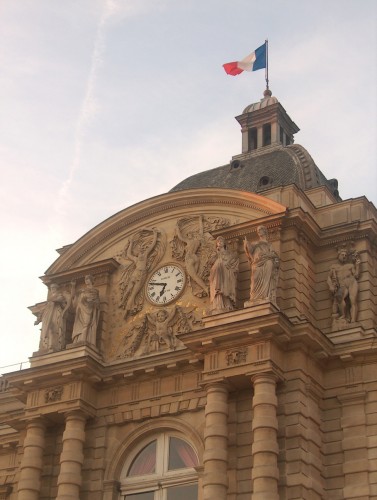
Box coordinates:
[103,215,230,360]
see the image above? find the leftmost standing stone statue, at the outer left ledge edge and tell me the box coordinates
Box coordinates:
[34,283,71,352]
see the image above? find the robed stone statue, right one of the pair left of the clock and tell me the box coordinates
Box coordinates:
[72,275,100,345]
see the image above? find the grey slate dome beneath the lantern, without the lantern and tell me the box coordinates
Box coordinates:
[170,144,337,196]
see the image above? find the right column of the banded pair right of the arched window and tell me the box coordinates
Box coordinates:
[251,373,279,500]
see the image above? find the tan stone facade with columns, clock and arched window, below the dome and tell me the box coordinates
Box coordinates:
[0,94,377,500]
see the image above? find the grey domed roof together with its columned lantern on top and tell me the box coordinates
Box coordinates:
[171,93,340,201]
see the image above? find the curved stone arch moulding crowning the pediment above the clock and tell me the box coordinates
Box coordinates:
[46,188,286,275]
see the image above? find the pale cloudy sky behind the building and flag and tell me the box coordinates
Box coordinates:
[0,0,377,373]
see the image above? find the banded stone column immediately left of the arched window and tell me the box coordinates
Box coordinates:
[56,411,86,500]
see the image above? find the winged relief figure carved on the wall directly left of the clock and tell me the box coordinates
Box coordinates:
[119,228,158,318]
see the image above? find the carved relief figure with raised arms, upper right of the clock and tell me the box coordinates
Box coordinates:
[176,216,208,297]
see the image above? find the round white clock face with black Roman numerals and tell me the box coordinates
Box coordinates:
[146,264,186,305]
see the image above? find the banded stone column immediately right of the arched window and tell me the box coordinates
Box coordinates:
[203,382,228,500]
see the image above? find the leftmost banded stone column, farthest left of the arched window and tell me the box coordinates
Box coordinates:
[17,418,46,500]
